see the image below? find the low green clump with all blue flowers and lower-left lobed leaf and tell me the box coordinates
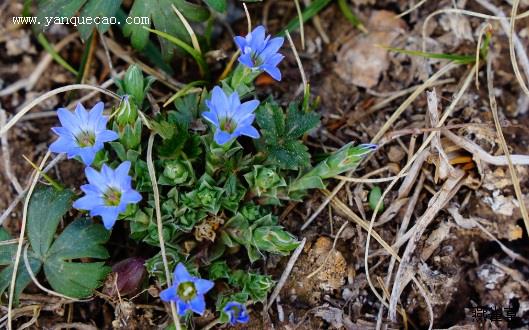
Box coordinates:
[0,27,376,324]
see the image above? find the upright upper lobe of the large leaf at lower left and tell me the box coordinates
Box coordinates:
[27,187,73,258]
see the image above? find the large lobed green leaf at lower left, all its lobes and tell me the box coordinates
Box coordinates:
[0,187,110,301]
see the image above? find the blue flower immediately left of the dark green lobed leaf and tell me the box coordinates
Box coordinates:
[202,86,259,145]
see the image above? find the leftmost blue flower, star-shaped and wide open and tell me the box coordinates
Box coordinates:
[50,102,119,165]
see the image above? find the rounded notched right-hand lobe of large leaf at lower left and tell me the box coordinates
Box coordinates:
[44,219,110,298]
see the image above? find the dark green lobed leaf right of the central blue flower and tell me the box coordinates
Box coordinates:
[256,100,319,170]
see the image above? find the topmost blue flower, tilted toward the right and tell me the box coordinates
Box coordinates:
[235,25,284,81]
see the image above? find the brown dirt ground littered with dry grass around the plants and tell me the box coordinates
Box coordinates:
[0,0,529,329]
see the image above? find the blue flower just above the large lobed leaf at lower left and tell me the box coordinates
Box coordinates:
[73,161,141,230]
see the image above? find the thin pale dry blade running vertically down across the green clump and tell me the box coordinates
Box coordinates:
[147,133,182,330]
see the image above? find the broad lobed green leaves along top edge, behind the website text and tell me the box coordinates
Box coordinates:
[37,0,227,60]
